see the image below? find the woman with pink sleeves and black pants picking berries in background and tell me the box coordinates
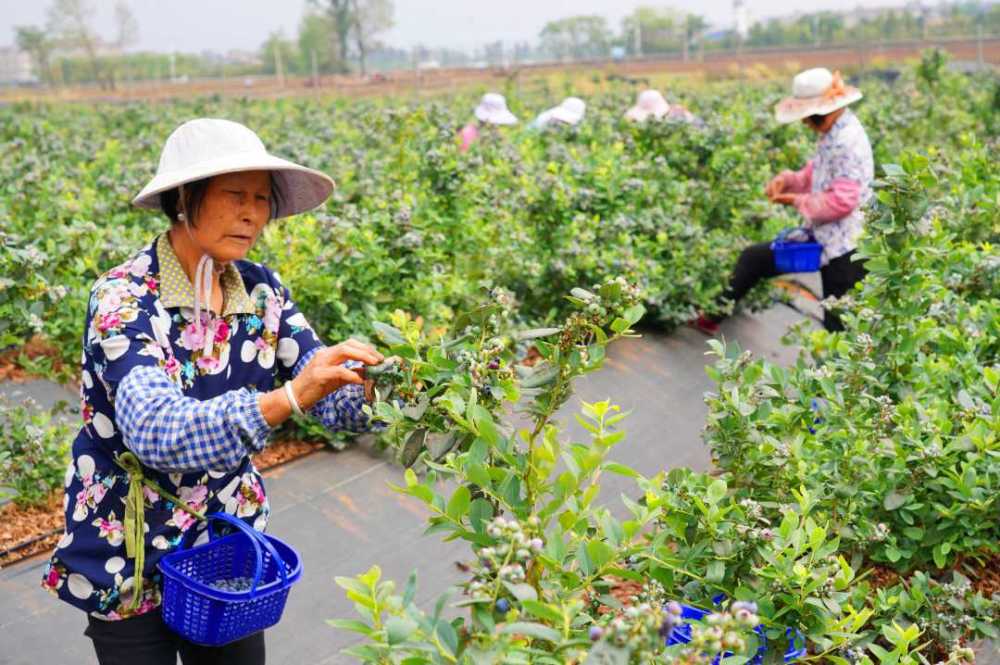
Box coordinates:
[695,68,874,334]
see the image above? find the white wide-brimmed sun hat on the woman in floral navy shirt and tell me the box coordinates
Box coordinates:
[132,118,334,218]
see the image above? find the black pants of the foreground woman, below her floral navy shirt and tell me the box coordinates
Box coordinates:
[83,611,264,665]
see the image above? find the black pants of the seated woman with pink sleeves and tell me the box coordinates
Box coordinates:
[723,242,866,332]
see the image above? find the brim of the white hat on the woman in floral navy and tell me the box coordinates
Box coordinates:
[132,152,335,219]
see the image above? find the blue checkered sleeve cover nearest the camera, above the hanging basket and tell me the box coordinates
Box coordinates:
[115,367,271,473]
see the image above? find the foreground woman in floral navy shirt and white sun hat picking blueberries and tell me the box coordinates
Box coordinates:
[42,119,382,665]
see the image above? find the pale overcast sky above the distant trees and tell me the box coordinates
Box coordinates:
[0,0,905,52]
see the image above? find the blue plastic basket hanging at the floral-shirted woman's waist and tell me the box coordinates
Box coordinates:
[159,513,302,646]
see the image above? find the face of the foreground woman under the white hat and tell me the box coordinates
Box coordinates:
[191,171,271,263]
